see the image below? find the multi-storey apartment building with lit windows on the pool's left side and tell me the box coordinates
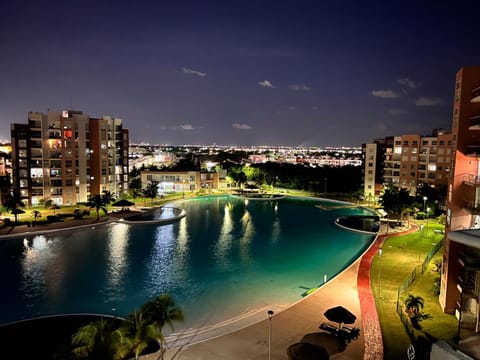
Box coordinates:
[11,110,129,205]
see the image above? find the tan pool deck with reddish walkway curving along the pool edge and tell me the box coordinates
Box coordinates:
[0,215,417,360]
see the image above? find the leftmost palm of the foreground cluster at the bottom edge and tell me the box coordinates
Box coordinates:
[72,317,123,360]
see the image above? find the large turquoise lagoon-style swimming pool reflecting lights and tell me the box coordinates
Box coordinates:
[0,196,374,329]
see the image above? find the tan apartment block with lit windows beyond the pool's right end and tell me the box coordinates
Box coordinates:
[362,129,453,197]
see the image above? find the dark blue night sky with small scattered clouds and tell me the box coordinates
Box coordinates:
[0,0,480,146]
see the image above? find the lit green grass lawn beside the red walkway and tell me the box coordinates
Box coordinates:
[370,219,458,359]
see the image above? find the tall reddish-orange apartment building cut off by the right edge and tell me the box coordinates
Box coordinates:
[439,66,480,332]
